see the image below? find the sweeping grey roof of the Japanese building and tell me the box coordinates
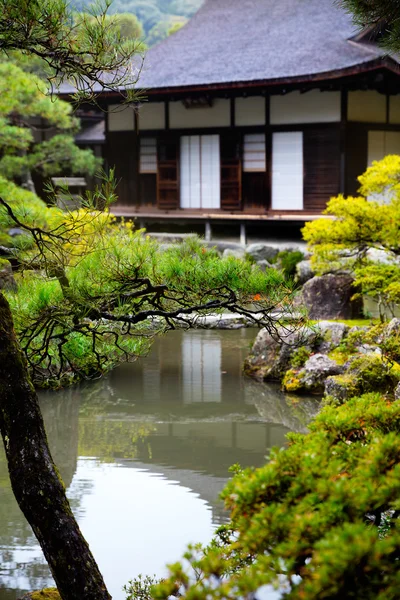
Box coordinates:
[139,0,390,90]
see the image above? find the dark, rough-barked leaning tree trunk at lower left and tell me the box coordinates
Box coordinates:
[0,294,111,600]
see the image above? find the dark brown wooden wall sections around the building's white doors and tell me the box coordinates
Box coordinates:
[105,123,376,212]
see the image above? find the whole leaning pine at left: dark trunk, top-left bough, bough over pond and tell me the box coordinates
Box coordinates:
[0,5,296,600]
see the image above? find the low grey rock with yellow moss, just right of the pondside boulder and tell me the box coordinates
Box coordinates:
[283,354,343,394]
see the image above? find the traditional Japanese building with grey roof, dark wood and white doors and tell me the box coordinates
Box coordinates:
[69,0,400,239]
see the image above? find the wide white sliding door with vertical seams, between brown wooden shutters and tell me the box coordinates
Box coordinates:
[180,135,221,209]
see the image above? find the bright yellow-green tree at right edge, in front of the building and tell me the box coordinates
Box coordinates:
[303,155,400,318]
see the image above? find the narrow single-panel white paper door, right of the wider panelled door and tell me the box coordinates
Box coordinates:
[272,131,303,210]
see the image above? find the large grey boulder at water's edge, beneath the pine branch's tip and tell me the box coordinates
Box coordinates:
[244,326,318,381]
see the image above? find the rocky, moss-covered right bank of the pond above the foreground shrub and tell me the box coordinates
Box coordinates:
[245,318,400,402]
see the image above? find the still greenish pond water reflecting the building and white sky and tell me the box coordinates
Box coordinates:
[0,329,316,600]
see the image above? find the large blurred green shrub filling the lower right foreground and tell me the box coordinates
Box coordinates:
[152,394,400,600]
